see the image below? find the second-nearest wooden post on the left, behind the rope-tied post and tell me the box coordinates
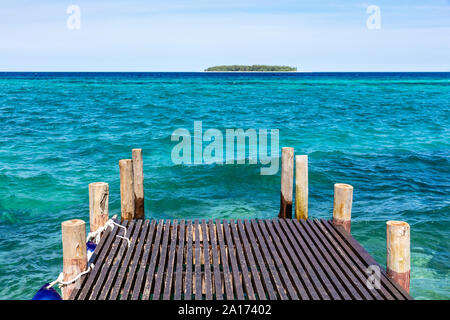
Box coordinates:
[89,182,109,232]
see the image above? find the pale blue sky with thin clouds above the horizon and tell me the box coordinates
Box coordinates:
[0,0,450,71]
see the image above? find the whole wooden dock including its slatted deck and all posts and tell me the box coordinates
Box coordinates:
[50,148,411,300]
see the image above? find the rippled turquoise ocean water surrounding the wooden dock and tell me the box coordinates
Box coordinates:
[0,73,450,299]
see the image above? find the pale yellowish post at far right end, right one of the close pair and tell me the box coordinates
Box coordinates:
[295,155,308,220]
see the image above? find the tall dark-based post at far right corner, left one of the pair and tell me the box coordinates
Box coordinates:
[278,147,294,219]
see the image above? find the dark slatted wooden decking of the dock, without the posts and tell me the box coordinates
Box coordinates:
[71,219,411,300]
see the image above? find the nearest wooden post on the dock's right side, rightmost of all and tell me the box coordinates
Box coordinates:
[386,221,411,293]
